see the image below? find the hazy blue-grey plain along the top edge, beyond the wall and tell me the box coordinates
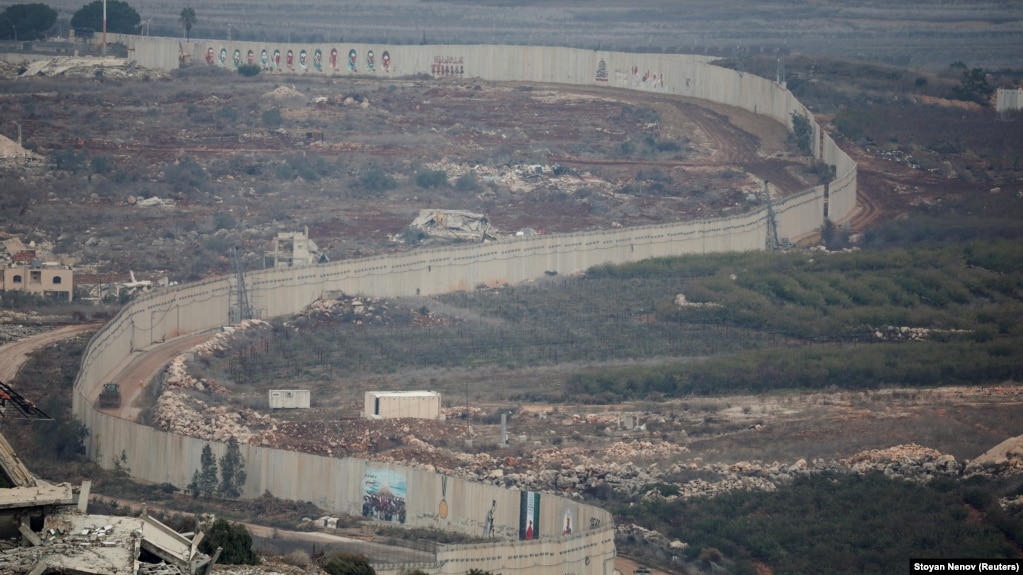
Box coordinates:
[48,0,1023,69]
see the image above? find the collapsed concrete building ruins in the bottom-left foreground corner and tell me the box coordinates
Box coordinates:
[0,435,220,575]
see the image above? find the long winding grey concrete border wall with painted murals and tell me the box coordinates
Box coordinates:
[73,37,856,575]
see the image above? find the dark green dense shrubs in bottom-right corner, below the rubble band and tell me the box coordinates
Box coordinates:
[615,474,1023,574]
